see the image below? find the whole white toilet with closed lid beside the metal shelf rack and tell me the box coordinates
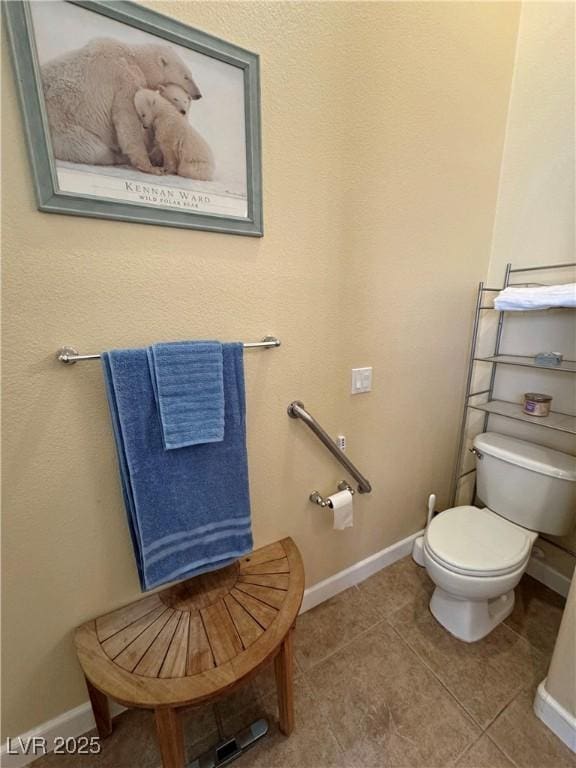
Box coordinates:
[419,432,576,643]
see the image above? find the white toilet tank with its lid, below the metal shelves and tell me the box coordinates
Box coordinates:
[474,432,576,536]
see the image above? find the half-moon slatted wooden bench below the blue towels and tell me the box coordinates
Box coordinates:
[75,538,304,768]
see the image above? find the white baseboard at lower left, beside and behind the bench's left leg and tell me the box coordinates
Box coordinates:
[0,701,126,768]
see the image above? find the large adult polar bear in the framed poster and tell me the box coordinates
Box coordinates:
[42,38,202,174]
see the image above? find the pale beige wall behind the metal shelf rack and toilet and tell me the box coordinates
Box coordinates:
[456,2,576,578]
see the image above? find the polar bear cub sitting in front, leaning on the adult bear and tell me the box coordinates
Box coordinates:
[134,86,214,181]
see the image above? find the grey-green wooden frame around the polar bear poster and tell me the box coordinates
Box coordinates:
[2,0,263,237]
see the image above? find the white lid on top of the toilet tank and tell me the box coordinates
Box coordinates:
[474,432,576,483]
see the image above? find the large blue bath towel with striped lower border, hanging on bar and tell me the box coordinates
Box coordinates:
[102,344,252,590]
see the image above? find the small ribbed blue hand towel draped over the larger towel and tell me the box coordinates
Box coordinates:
[148,341,224,450]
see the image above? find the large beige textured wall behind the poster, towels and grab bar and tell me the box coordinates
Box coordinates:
[3,2,518,737]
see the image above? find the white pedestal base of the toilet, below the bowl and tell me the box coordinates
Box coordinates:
[430,587,514,643]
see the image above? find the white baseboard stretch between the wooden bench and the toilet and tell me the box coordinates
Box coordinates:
[300,531,423,613]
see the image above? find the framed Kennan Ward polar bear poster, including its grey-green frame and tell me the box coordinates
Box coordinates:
[2,0,262,236]
